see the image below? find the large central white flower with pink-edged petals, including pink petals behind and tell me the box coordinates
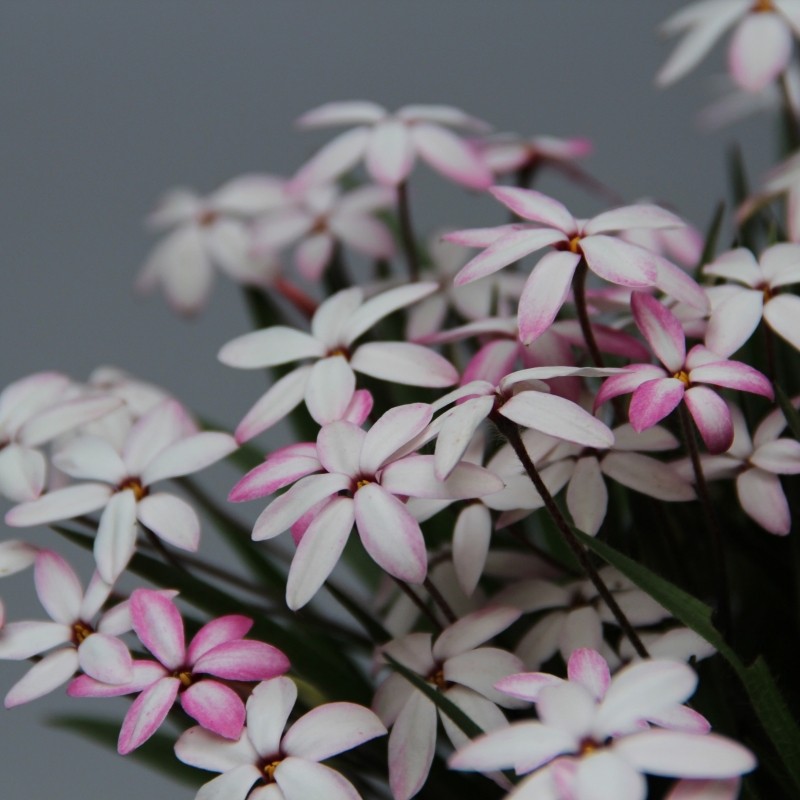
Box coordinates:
[229,403,503,609]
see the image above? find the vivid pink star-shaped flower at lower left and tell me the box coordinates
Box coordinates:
[69,589,289,755]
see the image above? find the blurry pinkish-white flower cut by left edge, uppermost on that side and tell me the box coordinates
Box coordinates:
[0,372,121,503]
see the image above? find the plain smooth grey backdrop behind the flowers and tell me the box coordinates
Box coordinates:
[0,0,772,800]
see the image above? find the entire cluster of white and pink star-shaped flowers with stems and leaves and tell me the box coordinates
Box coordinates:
[0,0,800,800]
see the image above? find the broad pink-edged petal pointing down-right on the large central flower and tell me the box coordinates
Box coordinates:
[355,483,428,583]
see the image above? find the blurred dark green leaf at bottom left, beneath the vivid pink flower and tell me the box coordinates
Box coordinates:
[46,714,204,789]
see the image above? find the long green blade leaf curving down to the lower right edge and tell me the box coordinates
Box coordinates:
[574,530,800,790]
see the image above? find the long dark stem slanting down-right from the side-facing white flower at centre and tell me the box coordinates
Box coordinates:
[489,410,650,658]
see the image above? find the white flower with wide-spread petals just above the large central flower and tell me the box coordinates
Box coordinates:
[219,283,458,442]
